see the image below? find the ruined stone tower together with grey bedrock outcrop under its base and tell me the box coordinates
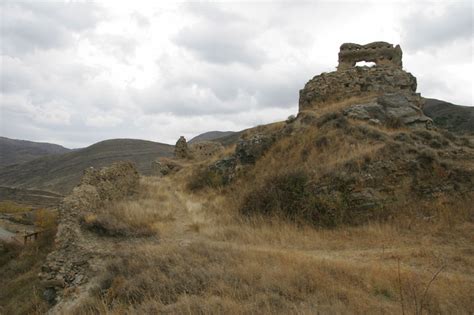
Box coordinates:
[299,42,432,126]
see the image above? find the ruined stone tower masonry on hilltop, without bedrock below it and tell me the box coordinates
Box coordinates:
[299,42,423,111]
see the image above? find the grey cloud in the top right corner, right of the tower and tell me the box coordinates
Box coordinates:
[402,1,473,51]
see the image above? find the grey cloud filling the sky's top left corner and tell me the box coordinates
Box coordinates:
[0,1,101,56]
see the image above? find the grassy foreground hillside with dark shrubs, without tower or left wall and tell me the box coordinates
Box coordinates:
[50,100,474,314]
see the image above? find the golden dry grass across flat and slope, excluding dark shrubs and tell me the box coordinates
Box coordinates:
[41,107,474,314]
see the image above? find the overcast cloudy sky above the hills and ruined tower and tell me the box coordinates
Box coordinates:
[0,0,474,148]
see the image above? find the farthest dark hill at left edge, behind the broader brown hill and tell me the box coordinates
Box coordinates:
[0,137,70,167]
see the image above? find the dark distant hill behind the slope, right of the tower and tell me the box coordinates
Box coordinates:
[423,98,474,134]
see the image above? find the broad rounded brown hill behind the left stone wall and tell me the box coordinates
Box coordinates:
[0,139,174,194]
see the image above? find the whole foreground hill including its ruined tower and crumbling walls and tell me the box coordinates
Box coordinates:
[23,42,474,314]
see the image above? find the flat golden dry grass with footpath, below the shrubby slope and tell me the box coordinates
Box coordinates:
[65,174,474,314]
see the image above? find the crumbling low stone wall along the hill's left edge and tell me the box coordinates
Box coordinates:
[40,162,139,304]
